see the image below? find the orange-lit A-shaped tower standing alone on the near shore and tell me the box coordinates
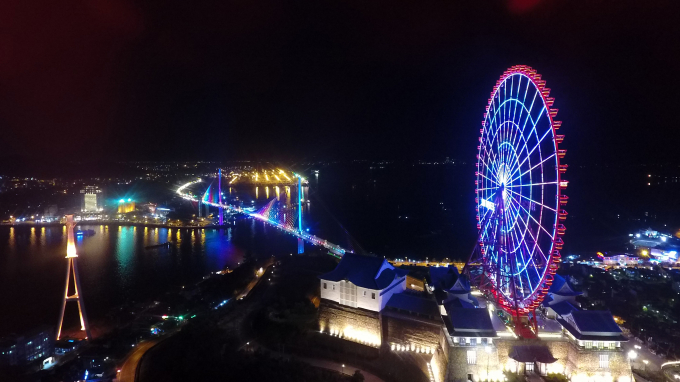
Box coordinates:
[57,215,92,340]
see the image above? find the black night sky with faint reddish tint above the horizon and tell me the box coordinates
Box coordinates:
[0,0,680,165]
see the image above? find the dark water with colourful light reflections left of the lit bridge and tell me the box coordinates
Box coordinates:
[0,219,295,336]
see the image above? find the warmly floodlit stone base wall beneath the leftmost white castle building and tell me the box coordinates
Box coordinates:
[319,300,381,347]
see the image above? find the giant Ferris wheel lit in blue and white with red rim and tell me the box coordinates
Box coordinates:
[471,65,567,326]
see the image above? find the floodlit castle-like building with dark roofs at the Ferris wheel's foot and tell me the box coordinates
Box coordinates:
[319,254,632,382]
